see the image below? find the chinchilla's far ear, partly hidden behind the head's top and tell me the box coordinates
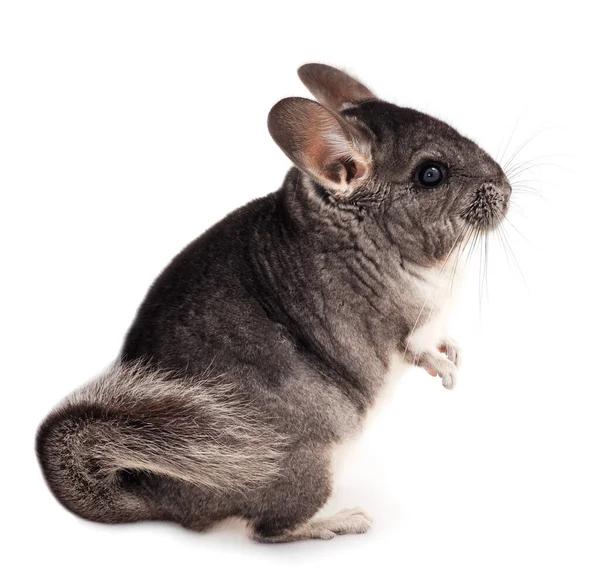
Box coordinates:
[298,63,377,111]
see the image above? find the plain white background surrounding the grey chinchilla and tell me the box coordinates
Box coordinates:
[0,0,600,581]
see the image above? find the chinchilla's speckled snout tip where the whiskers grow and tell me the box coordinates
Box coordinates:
[462,176,512,231]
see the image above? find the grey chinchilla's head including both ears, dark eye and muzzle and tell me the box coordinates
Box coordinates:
[268,64,511,265]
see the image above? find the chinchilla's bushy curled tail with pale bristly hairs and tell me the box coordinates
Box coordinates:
[36,363,285,523]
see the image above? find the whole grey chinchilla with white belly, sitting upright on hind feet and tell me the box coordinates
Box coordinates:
[36,64,511,542]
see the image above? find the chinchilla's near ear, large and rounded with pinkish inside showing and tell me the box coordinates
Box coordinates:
[268,97,372,198]
